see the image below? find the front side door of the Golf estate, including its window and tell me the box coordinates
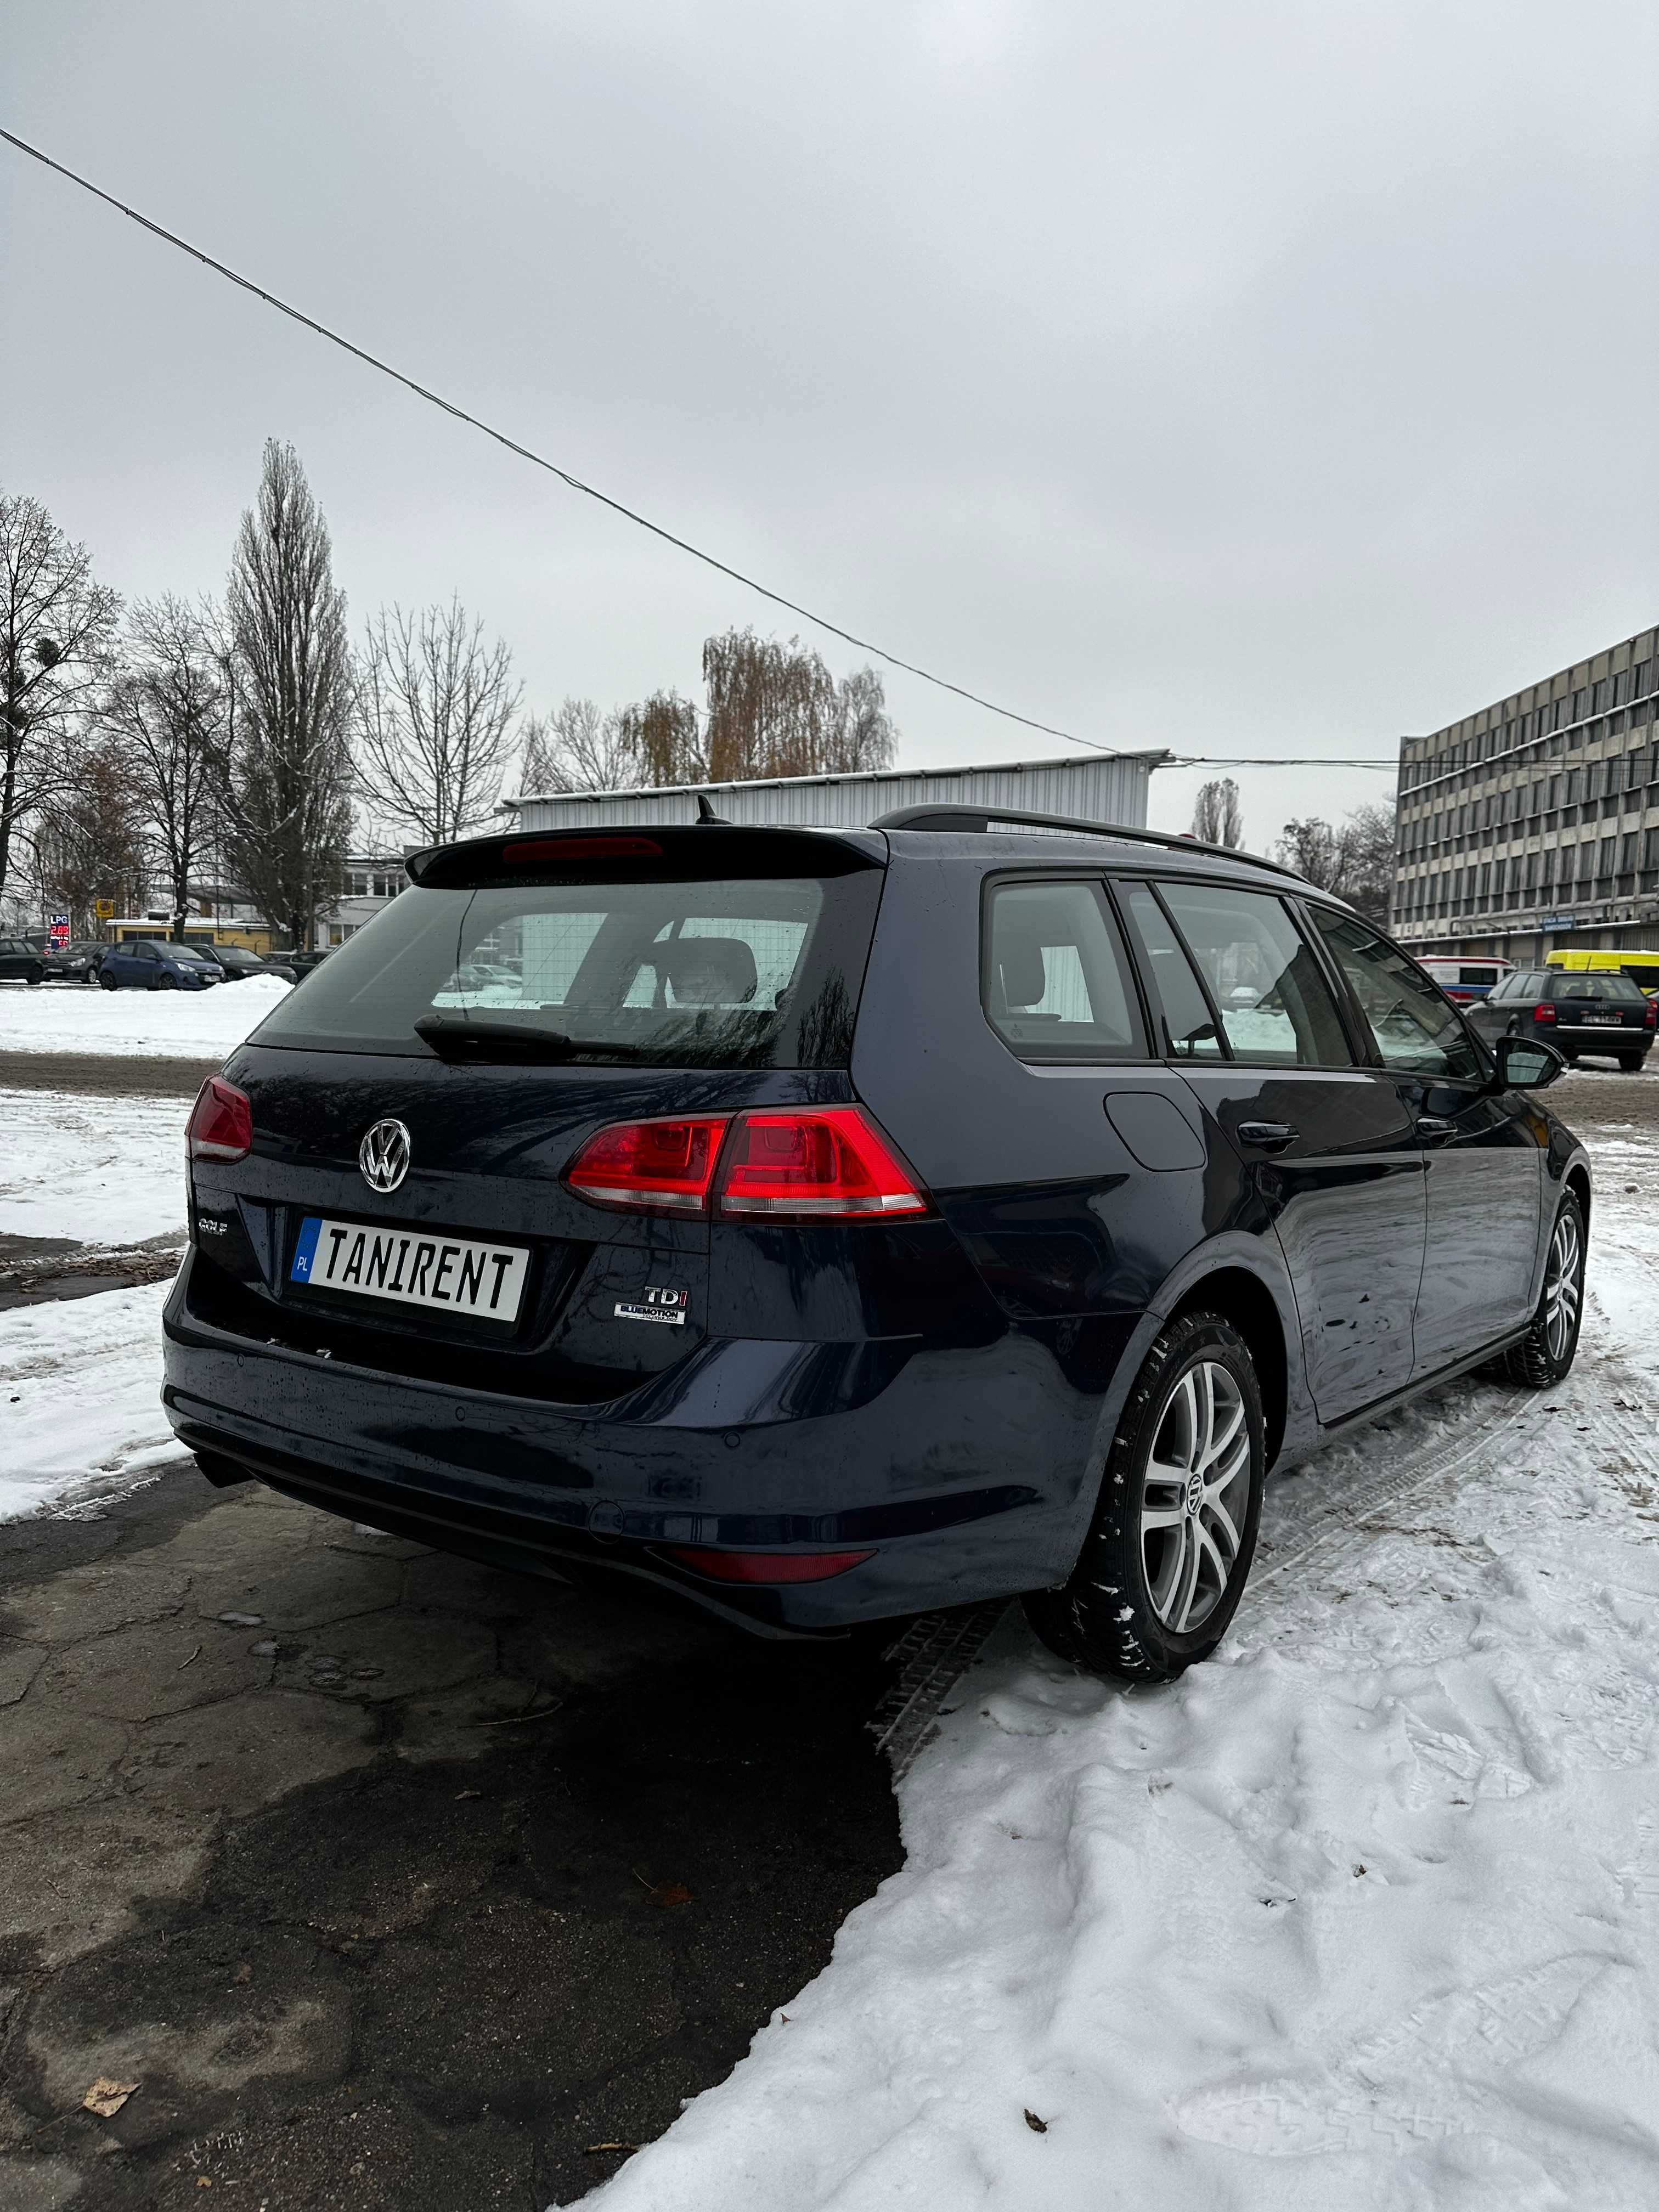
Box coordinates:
[1312,907,1548,1376]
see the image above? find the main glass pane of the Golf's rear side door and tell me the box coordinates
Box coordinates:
[1159,883,1354,1068]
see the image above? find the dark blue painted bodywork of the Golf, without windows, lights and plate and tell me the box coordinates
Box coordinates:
[166,832,1588,1633]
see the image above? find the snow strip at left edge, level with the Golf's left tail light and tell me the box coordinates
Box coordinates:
[0,1084,191,1245]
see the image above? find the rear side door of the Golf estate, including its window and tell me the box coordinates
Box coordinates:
[1121,878,1425,1423]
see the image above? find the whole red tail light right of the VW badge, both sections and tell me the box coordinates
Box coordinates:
[566,1106,931,1221]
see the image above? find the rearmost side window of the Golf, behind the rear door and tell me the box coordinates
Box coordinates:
[980,883,1146,1059]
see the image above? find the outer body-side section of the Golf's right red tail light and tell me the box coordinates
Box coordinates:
[716,1106,929,1221]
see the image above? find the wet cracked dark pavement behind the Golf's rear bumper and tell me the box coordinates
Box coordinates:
[0,1469,900,2212]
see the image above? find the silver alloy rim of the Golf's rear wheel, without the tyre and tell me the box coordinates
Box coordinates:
[1142,1361,1250,1635]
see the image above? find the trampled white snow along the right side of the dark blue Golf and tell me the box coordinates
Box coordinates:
[595,1167,1659,2212]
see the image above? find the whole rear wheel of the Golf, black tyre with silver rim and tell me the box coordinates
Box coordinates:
[1024,1314,1267,1681]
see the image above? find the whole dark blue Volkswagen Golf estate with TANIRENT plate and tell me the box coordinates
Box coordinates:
[166,810,1590,1681]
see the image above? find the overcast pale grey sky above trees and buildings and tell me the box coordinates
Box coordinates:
[0,0,1659,843]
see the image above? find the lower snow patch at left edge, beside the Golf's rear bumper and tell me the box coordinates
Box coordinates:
[0,1283,179,1520]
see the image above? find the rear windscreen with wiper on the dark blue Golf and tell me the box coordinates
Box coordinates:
[245,870,883,1068]
